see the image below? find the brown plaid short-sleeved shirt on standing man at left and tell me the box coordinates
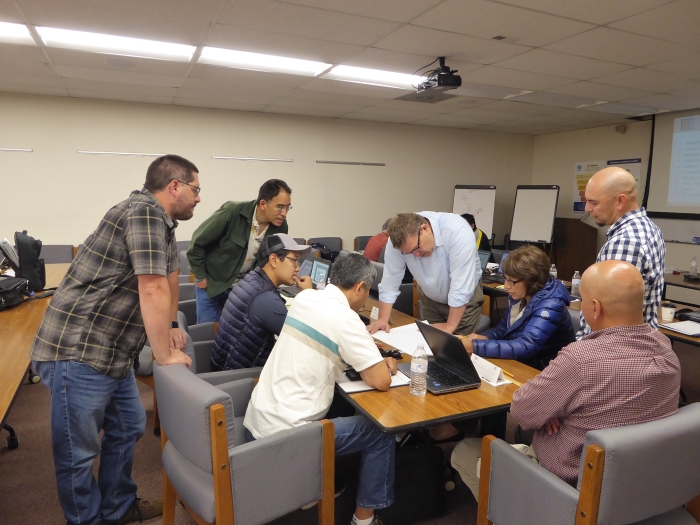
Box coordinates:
[30,189,179,378]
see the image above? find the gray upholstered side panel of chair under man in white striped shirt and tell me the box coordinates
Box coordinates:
[229,422,332,523]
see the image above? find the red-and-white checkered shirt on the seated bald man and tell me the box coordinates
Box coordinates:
[510,324,681,485]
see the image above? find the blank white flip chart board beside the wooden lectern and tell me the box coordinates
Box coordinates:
[510,186,559,242]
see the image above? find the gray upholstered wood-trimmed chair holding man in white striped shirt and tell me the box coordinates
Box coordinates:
[154,364,335,525]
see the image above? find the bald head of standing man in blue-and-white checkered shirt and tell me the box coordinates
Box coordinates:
[586,166,639,226]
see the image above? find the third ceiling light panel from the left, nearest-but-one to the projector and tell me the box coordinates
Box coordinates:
[197,47,333,77]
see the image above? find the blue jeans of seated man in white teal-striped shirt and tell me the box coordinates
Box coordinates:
[331,416,396,509]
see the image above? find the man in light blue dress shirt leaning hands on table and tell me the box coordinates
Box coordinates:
[367,211,484,335]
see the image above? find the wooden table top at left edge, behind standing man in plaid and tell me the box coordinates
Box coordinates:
[0,264,70,422]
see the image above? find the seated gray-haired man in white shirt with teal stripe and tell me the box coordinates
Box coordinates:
[243,253,396,525]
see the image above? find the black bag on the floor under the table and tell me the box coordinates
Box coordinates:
[377,444,446,525]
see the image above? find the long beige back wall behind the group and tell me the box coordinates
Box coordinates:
[0,93,533,248]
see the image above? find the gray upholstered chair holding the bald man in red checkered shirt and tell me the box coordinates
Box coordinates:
[477,403,700,525]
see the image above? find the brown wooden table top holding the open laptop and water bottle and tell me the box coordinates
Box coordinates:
[338,299,539,433]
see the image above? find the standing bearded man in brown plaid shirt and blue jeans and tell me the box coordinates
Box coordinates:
[31,155,200,525]
